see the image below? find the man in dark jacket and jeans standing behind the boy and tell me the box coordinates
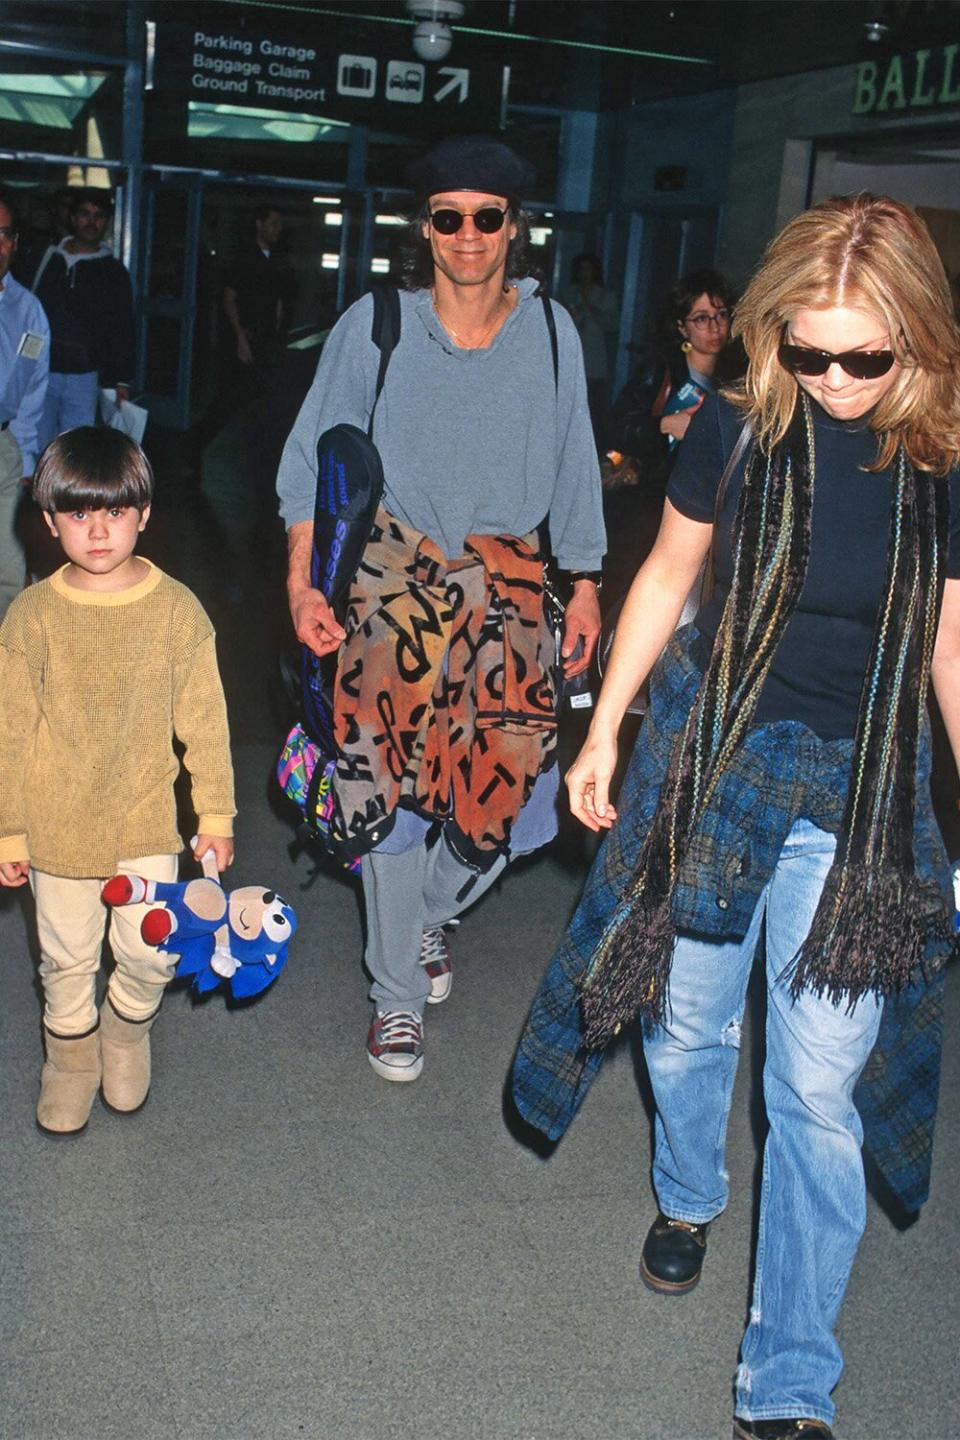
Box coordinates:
[22,189,134,449]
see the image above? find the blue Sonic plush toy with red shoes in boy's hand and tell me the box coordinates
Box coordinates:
[102,857,296,999]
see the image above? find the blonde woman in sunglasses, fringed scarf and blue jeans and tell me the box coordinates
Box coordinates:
[514,194,960,1440]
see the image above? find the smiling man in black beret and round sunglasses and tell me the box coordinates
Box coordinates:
[278,135,604,1080]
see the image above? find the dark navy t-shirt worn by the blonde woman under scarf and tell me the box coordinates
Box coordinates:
[666,396,960,740]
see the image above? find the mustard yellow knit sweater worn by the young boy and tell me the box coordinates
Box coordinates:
[0,564,236,877]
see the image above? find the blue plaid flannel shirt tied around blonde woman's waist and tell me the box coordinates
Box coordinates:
[512,625,951,1211]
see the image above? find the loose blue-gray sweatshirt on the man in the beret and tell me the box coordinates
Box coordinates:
[276,279,606,570]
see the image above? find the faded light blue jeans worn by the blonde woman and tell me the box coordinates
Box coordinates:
[645,819,882,1424]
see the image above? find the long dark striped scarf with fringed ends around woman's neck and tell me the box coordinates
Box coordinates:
[583,396,948,1048]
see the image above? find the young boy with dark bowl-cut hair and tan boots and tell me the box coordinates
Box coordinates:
[0,426,236,1135]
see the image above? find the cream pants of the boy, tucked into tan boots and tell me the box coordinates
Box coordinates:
[30,855,178,1037]
